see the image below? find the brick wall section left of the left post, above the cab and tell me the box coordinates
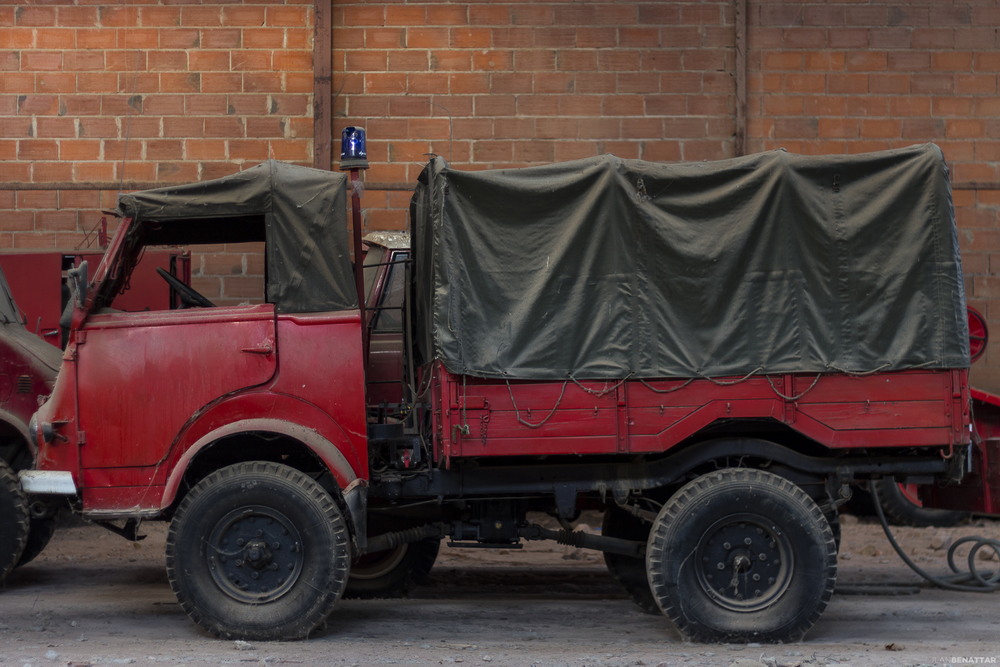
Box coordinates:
[0,0,313,302]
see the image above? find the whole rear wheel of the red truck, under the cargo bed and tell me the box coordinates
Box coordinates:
[646,468,837,643]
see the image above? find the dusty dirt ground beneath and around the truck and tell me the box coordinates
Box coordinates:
[0,516,1000,667]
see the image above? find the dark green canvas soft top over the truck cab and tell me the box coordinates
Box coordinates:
[117,160,358,313]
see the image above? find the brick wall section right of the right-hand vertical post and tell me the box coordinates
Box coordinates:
[748,0,1000,391]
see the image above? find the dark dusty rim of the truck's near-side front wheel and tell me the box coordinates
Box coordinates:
[207,505,303,604]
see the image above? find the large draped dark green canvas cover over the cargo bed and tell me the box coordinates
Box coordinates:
[411,144,969,379]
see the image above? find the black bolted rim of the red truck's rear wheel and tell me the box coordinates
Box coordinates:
[695,514,795,613]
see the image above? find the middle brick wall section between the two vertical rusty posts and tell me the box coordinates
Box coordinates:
[333,0,735,229]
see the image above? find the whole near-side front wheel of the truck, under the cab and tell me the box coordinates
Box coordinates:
[167,461,351,640]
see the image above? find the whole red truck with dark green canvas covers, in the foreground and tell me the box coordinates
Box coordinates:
[15,145,997,642]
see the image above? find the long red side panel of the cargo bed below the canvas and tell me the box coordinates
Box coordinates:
[434,367,968,458]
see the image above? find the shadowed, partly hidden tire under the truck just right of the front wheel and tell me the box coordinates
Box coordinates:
[344,537,441,600]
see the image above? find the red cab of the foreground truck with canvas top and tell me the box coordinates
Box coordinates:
[27,163,367,520]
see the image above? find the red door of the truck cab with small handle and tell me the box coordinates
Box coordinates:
[75,305,277,470]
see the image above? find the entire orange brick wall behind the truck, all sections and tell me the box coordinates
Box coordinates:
[0,0,1000,391]
